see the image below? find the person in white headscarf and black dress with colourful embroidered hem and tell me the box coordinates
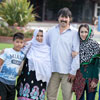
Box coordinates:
[17,30,51,100]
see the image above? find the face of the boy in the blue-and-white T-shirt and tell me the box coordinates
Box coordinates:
[13,39,24,51]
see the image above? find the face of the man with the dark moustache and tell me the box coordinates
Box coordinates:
[58,15,71,27]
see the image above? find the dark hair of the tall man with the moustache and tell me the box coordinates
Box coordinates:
[58,7,72,18]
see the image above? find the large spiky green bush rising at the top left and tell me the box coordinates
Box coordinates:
[0,0,35,26]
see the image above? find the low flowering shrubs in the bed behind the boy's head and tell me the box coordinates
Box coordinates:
[0,26,34,38]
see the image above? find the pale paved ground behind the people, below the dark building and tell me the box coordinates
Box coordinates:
[26,22,100,41]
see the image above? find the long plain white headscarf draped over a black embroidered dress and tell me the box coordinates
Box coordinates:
[26,29,51,82]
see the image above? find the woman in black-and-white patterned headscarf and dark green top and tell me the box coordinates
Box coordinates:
[72,24,100,100]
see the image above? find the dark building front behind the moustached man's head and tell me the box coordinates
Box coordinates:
[46,0,94,23]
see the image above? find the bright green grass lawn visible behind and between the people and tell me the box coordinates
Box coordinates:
[0,43,98,100]
